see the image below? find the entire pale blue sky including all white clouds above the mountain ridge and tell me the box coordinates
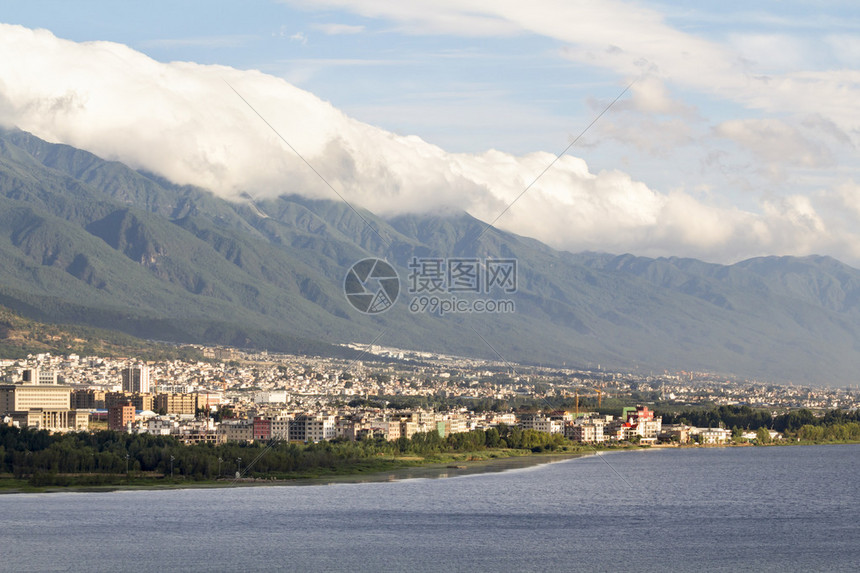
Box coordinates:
[0,0,860,266]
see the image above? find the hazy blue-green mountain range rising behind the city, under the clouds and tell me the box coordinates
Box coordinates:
[0,130,860,385]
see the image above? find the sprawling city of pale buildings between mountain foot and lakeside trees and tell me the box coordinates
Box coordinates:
[0,345,860,444]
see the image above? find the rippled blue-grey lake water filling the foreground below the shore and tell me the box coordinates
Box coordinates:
[0,445,860,571]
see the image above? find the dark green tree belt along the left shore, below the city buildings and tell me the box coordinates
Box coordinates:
[0,418,569,485]
